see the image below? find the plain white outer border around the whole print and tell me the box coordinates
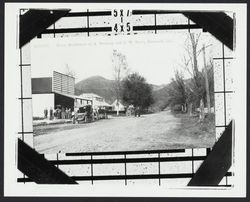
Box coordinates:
[4,3,247,197]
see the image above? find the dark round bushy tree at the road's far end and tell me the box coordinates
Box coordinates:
[122,73,153,109]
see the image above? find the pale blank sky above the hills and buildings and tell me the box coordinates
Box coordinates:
[31,32,214,85]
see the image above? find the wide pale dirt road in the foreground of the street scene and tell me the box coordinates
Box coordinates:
[34,111,211,153]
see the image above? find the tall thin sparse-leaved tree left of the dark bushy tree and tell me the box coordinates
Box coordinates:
[112,50,128,116]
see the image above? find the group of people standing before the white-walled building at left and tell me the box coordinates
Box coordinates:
[44,107,72,120]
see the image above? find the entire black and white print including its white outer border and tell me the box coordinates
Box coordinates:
[2,3,246,197]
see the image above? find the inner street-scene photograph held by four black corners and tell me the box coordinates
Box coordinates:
[31,31,215,153]
